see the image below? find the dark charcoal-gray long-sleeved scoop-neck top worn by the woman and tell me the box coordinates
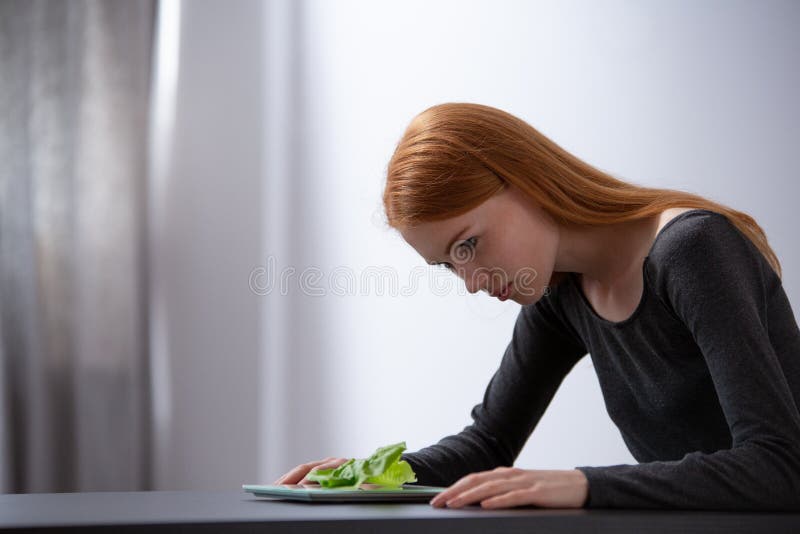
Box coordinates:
[403,209,800,510]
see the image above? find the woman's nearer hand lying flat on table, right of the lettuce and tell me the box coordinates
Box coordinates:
[431,467,589,508]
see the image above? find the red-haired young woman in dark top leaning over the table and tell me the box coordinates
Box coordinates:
[276,103,800,510]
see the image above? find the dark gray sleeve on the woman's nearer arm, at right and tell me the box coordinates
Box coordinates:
[576,215,800,510]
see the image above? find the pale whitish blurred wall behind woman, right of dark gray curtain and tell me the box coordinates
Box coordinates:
[150,0,800,489]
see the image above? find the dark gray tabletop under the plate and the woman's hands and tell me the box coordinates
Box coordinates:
[0,491,800,534]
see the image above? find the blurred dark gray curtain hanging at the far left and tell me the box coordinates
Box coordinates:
[0,0,155,493]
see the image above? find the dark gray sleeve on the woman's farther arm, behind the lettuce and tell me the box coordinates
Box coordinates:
[403,294,586,486]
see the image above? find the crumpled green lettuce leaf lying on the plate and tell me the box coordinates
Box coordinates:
[306,441,417,489]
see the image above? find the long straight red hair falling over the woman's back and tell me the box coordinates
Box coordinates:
[383,103,782,278]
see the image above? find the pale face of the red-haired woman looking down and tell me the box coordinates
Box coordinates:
[400,184,559,305]
